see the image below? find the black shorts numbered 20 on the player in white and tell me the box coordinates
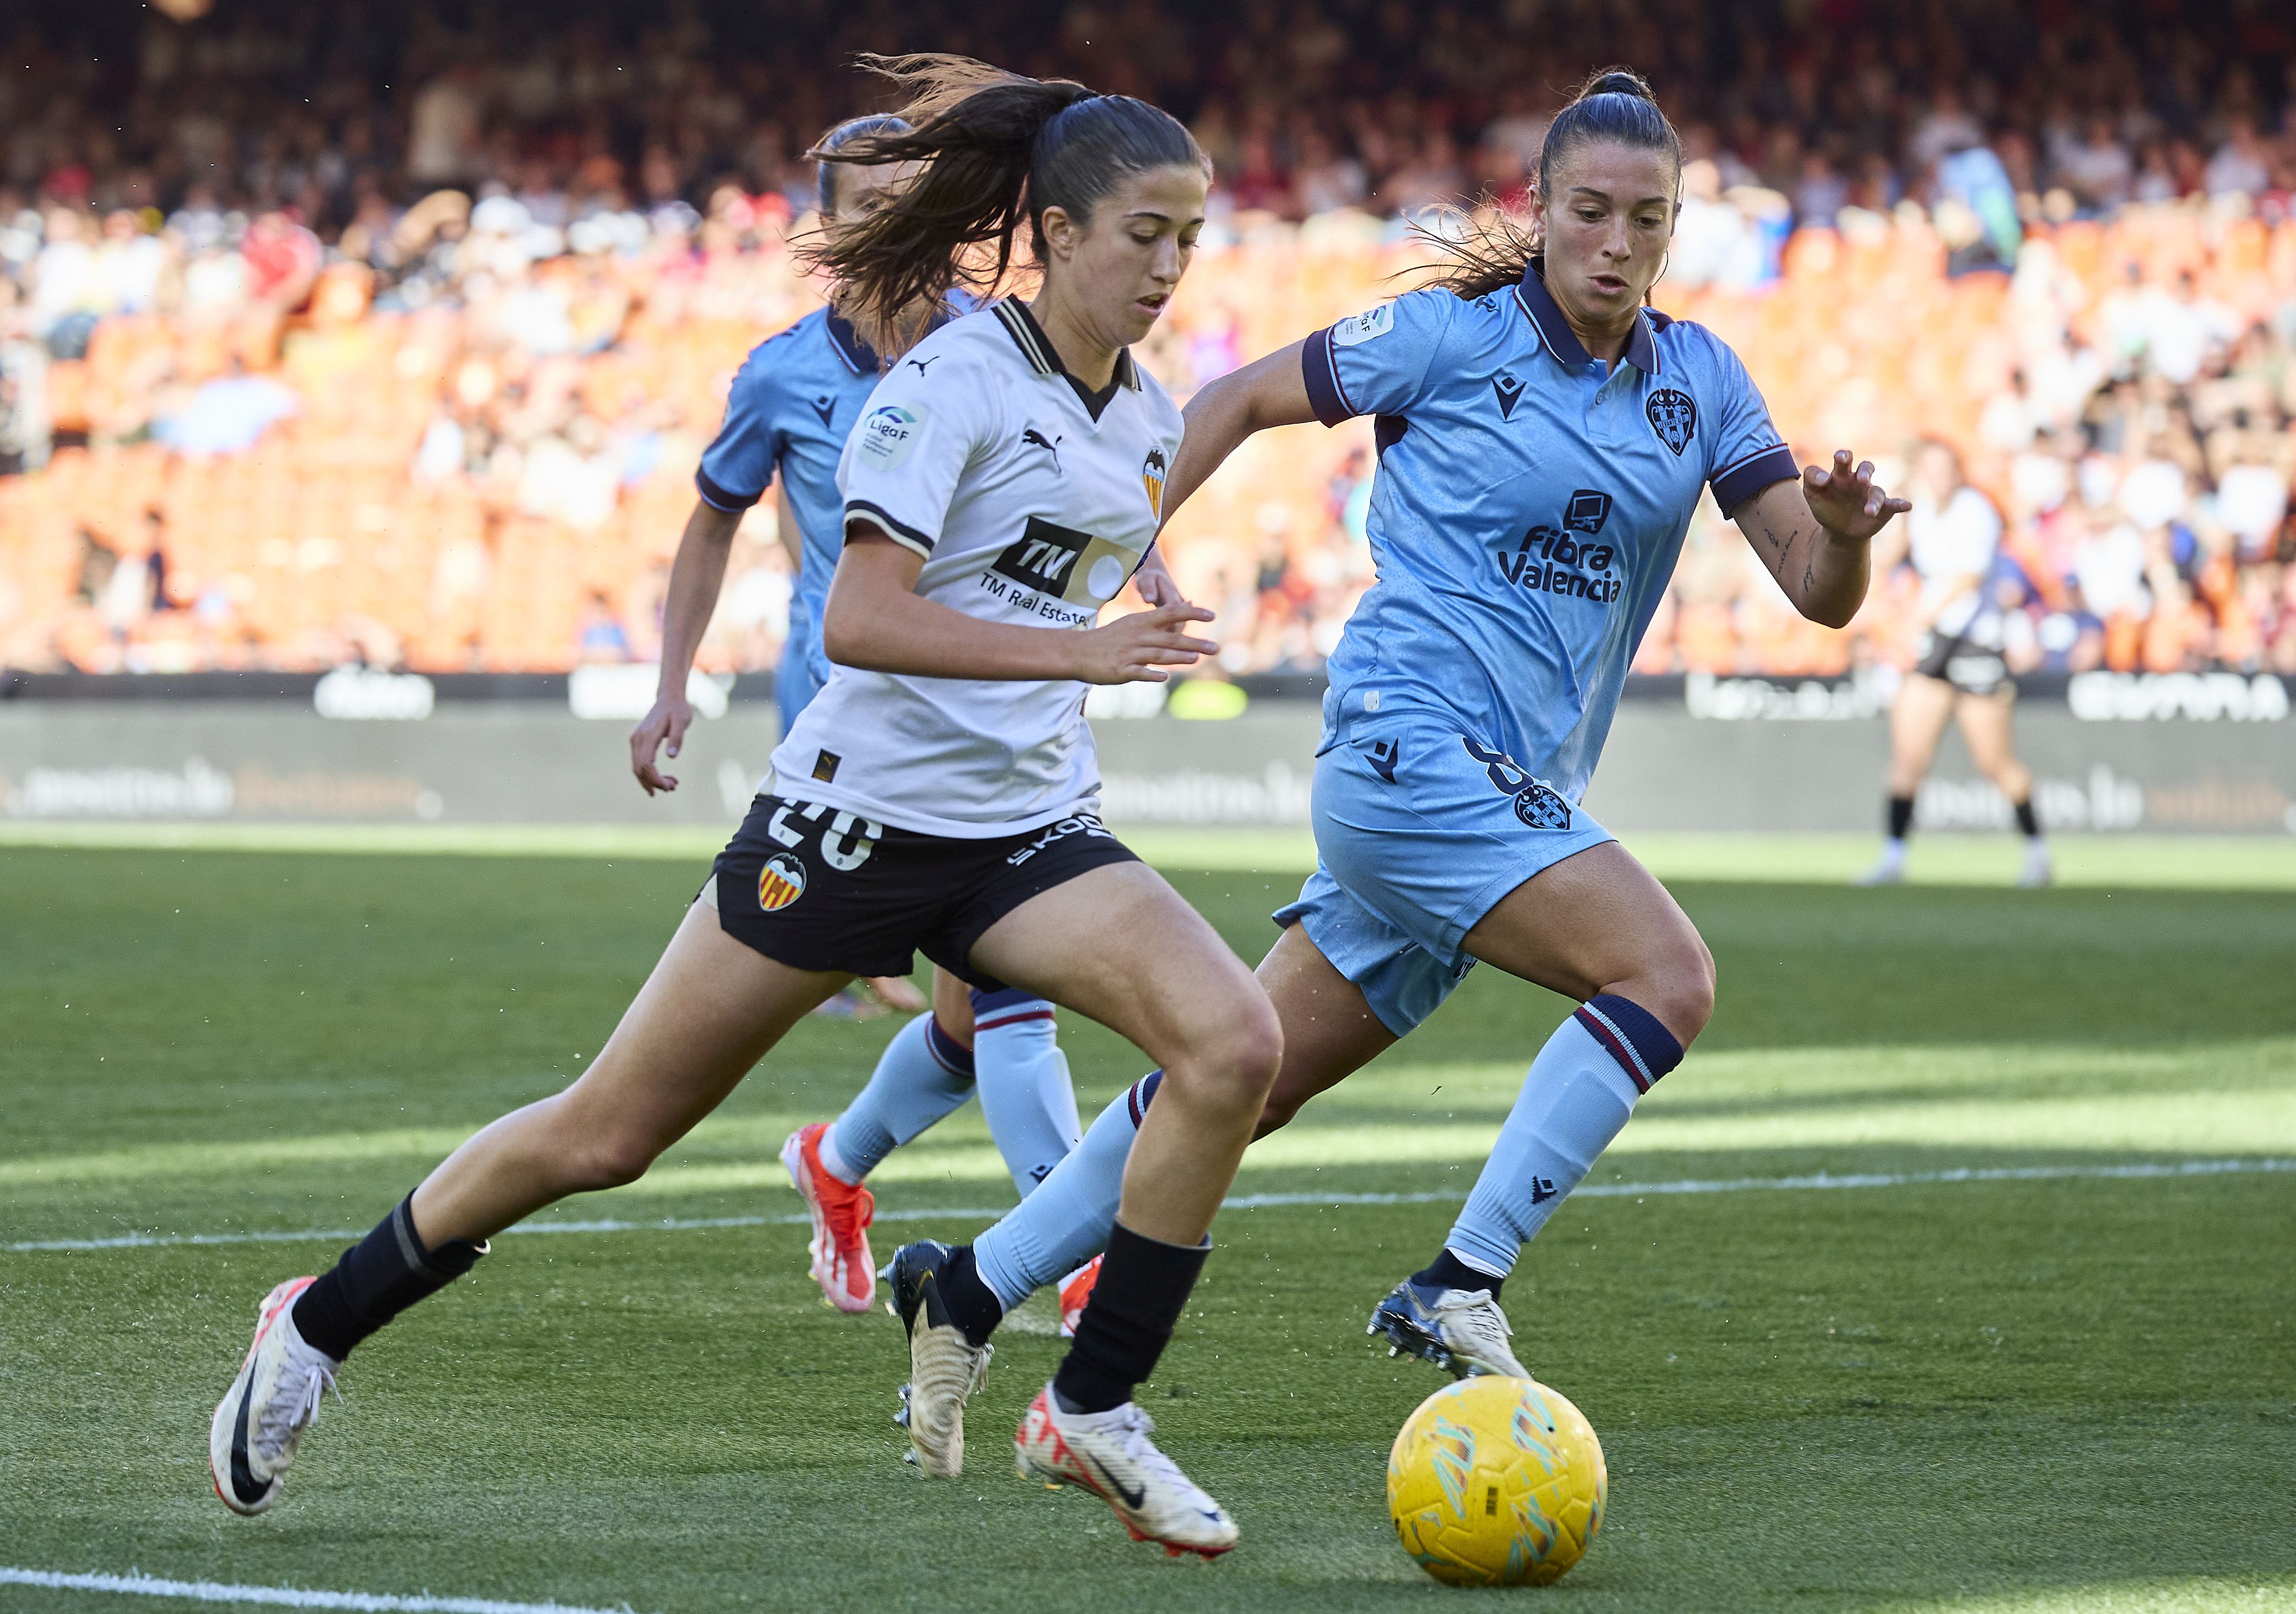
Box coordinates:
[712,797,1139,992]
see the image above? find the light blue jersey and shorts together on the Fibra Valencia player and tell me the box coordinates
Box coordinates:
[1277,259,1798,1035]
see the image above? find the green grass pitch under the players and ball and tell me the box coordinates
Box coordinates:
[0,838,2296,1614]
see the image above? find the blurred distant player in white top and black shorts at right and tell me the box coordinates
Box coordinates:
[1857,439,2050,886]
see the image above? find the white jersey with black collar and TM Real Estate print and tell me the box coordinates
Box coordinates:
[767,299,1180,838]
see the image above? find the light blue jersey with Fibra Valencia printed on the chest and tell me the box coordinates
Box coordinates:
[1304,273,1798,802]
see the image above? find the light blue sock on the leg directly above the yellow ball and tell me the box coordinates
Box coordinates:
[1444,994,1683,1279]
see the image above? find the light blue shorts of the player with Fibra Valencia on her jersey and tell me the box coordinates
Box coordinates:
[1274,712,1614,1038]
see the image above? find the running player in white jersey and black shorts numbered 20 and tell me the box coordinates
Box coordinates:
[209,57,1281,1554]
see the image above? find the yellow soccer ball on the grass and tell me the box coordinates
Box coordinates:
[1387,1377,1609,1586]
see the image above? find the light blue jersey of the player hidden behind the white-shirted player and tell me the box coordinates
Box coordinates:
[693,308,900,733]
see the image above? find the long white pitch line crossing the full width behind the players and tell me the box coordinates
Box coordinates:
[0,1157,2296,1256]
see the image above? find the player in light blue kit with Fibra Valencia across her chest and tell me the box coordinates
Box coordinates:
[895,71,1906,1373]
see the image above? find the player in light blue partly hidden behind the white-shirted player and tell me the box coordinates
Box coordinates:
[629,117,1125,1313]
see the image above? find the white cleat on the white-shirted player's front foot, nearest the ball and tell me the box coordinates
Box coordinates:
[1013,1384,1235,1559]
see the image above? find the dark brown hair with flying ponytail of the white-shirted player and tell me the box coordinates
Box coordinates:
[799,55,1210,335]
